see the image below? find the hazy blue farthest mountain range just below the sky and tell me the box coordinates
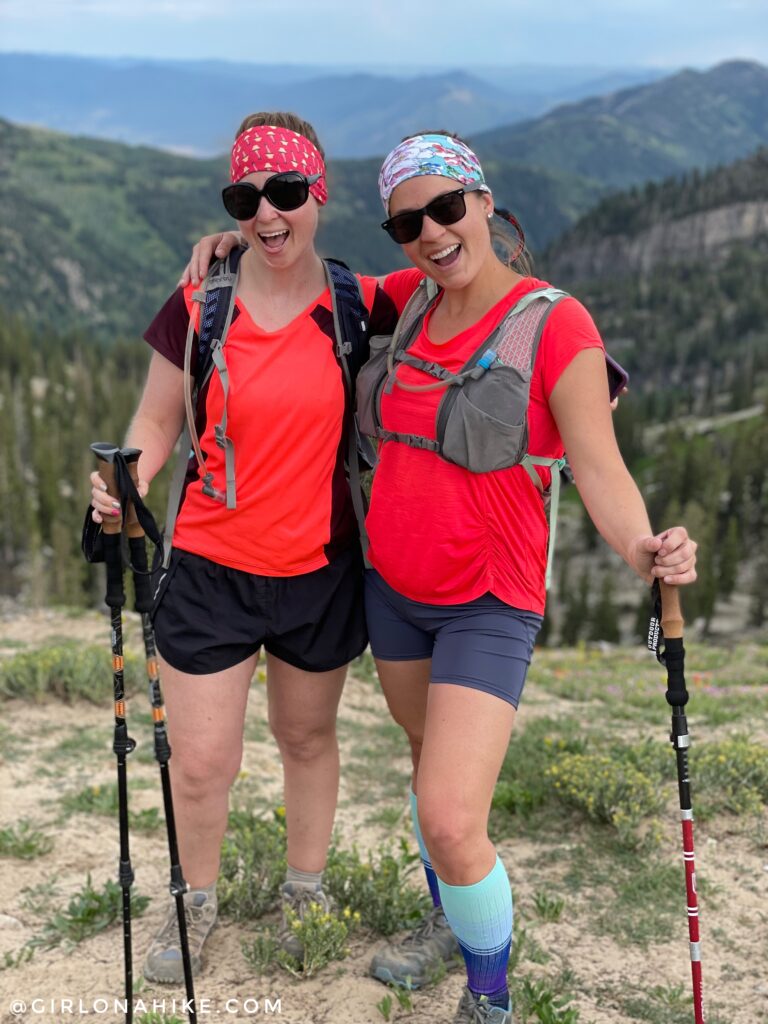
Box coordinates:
[0,53,662,157]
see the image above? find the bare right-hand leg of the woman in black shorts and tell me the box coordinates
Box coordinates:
[266,654,347,871]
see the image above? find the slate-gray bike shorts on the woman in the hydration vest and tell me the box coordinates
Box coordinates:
[366,569,542,708]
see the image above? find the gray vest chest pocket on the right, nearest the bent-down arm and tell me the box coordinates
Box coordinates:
[437,367,529,473]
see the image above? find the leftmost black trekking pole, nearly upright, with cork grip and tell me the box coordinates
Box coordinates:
[91,442,136,1024]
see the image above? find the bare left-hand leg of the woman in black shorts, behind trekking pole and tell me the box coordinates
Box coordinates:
[162,654,258,889]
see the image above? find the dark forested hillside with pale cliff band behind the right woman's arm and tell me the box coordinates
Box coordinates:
[542,150,768,637]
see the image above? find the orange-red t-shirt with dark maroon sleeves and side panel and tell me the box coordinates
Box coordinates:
[144,278,396,577]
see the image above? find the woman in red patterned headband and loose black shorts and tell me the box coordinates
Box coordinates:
[92,114,396,982]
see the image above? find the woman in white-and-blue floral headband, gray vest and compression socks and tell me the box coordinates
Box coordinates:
[185,132,696,1024]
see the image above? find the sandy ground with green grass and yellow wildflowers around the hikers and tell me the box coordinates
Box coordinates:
[0,611,768,1024]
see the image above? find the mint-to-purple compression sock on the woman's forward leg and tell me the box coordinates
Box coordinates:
[439,856,513,1009]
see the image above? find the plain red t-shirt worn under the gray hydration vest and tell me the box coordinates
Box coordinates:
[367,269,603,613]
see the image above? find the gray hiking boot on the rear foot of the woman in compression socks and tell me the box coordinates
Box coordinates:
[370,906,461,988]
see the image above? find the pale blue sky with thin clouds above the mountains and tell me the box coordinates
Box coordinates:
[0,0,768,69]
